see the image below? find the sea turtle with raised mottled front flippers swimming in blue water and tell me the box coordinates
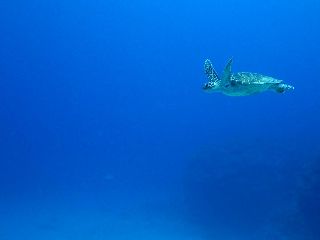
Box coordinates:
[203,58,294,96]
